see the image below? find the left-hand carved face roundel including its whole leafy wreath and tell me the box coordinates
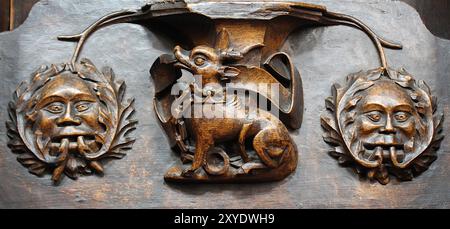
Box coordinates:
[7,59,137,184]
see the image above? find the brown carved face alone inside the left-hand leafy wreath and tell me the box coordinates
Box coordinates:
[32,72,104,159]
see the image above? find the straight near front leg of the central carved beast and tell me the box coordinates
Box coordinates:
[181,136,214,177]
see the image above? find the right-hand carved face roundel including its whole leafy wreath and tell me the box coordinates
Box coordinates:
[322,69,442,184]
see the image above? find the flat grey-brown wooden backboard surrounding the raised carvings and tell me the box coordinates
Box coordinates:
[0,0,450,208]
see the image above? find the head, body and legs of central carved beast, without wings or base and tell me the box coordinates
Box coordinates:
[169,30,297,179]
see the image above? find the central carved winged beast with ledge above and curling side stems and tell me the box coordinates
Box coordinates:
[51,1,408,182]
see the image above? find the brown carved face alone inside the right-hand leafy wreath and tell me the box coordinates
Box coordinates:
[347,80,431,166]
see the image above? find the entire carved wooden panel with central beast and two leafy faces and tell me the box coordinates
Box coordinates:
[0,0,450,208]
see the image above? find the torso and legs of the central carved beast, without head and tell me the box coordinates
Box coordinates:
[179,87,297,175]
